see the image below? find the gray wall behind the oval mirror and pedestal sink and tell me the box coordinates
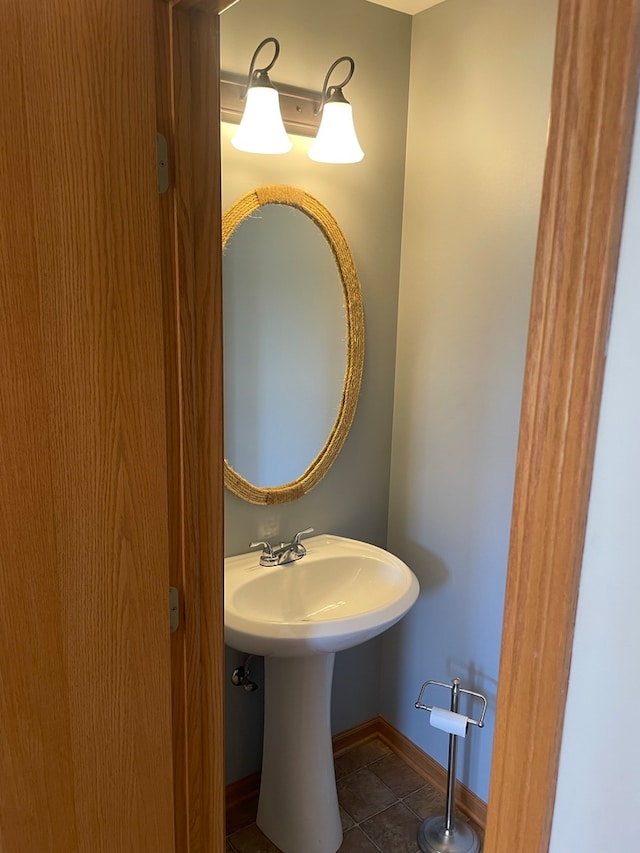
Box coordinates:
[220,0,411,781]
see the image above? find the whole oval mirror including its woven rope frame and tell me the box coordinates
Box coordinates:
[222,185,364,504]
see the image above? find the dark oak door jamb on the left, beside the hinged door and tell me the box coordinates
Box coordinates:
[154,0,225,853]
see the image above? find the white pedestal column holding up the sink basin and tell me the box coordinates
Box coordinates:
[256,654,342,853]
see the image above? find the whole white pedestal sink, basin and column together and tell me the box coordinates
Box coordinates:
[224,535,419,853]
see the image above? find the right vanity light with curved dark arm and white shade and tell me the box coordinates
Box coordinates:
[309,56,364,163]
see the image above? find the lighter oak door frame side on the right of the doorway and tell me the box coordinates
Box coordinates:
[485,0,640,853]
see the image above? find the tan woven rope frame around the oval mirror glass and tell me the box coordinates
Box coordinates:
[222,184,364,505]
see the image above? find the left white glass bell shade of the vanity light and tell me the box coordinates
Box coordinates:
[231,86,291,154]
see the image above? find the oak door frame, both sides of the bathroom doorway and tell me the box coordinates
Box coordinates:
[157,0,640,853]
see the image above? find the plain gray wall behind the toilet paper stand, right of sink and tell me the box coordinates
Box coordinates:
[381,0,557,800]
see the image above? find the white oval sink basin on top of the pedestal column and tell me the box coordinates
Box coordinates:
[224,535,419,657]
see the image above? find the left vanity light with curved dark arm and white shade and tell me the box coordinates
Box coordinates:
[231,36,291,154]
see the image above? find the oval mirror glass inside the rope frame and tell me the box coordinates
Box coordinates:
[223,204,347,486]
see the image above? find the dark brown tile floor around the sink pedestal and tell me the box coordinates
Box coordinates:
[227,738,482,853]
